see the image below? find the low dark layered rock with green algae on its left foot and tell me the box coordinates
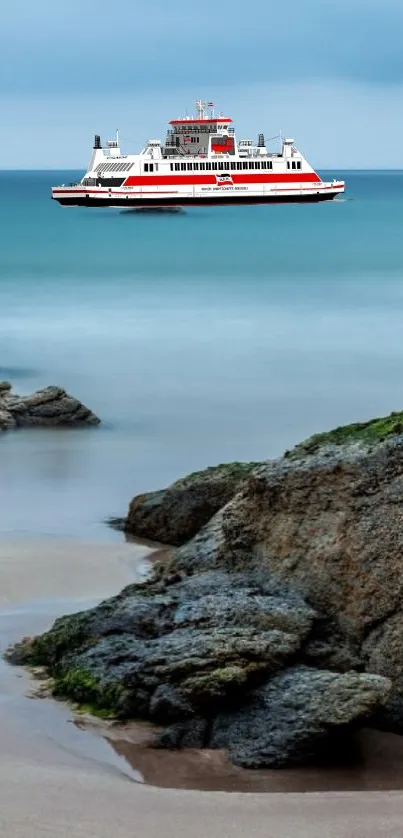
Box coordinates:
[9,573,315,724]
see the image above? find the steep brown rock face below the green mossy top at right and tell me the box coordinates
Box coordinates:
[175,437,403,648]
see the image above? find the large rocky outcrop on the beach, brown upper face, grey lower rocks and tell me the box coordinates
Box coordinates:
[11,415,403,767]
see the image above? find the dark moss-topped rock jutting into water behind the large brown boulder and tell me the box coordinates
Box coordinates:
[123,463,257,546]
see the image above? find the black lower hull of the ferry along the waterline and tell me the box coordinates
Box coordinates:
[53,190,340,209]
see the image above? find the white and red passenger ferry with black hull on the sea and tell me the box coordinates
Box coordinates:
[52,100,345,208]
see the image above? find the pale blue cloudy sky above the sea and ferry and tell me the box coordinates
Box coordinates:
[0,0,403,169]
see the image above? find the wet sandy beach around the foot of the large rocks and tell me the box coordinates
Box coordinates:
[0,539,403,838]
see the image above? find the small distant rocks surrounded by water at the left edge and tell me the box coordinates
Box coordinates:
[0,381,100,431]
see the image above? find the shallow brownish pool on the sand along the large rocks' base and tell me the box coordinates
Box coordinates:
[76,717,403,792]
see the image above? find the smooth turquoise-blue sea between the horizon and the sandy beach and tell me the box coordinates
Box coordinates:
[0,172,403,538]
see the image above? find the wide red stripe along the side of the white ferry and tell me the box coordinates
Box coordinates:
[123,171,321,186]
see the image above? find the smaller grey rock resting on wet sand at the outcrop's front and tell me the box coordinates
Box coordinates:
[209,667,391,768]
